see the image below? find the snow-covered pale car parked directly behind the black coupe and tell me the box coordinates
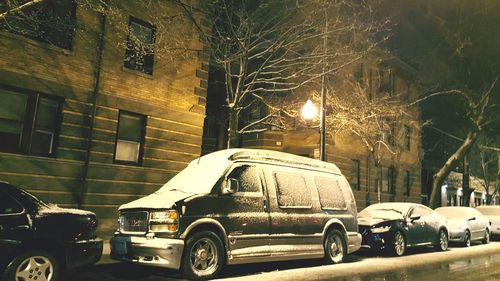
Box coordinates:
[435,207,490,247]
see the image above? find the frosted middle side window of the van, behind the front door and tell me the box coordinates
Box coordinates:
[274,172,312,208]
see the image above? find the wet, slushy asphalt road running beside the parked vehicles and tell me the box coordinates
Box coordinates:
[65,240,500,281]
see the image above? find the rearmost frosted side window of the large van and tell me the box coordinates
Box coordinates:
[314,176,346,209]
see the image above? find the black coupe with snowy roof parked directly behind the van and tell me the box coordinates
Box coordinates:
[358,202,448,256]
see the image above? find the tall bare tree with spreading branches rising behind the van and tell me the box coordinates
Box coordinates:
[179,0,378,147]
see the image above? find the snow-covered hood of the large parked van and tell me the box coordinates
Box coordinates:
[118,190,196,210]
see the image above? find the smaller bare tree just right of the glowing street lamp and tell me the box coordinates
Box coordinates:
[325,66,420,202]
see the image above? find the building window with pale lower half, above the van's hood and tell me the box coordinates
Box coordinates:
[115,111,146,165]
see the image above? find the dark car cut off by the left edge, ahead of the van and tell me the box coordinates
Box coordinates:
[0,182,103,281]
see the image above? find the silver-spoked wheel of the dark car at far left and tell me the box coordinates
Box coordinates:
[5,250,59,281]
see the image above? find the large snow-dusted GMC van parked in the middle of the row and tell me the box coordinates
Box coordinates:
[110,149,361,279]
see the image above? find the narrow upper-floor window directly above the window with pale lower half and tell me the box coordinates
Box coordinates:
[124,17,155,75]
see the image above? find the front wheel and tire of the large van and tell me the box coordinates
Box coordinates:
[181,231,224,280]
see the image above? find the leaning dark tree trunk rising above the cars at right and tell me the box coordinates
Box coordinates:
[429,130,479,209]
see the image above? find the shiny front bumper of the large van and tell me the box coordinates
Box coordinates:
[110,235,184,269]
